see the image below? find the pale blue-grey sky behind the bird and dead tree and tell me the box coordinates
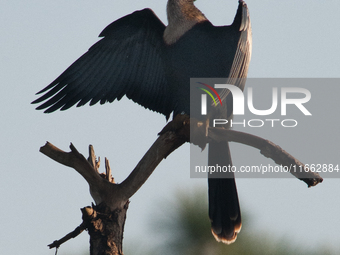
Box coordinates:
[0,0,340,255]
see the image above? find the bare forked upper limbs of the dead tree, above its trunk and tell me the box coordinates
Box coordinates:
[40,115,322,209]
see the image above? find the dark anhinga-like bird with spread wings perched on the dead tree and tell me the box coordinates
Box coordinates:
[32,0,251,243]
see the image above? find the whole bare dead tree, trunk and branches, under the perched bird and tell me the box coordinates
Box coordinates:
[40,115,322,255]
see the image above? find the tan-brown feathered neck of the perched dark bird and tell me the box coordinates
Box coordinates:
[163,0,207,45]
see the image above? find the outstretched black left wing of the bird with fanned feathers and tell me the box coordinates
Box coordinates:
[32,9,171,116]
